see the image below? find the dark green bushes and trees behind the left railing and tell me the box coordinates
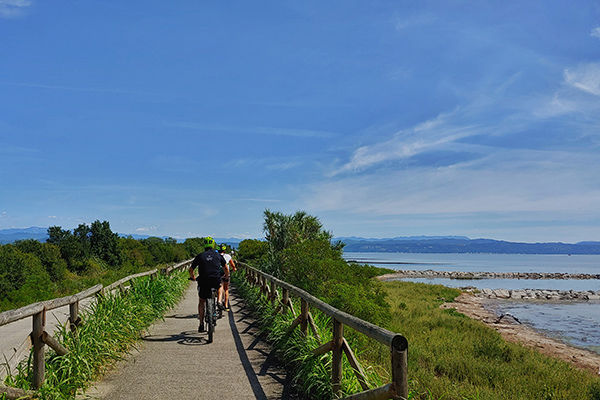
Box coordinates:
[0,221,202,311]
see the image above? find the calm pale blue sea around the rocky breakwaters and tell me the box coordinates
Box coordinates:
[344,252,600,354]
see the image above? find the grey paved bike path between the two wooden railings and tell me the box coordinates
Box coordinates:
[81,284,292,400]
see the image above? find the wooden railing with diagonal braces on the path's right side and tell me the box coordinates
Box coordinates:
[238,262,408,400]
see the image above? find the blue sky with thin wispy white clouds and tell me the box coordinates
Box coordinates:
[0,0,600,242]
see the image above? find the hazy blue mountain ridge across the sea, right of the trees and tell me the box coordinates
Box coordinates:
[336,236,600,254]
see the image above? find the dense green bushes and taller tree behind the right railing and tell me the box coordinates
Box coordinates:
[237,210,391,327]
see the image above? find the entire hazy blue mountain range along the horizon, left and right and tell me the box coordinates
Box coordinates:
[0,227,600,254]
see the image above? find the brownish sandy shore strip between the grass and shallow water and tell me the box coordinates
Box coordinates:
[440,293,600,374]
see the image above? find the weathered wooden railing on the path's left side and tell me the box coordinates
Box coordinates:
[0,260,192,399]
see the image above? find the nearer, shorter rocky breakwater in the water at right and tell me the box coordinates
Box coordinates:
[474,288,600,301]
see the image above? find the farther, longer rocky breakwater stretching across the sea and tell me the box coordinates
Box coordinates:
[379,269,600,281]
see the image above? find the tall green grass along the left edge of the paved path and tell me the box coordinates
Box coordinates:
[0,272,189,399]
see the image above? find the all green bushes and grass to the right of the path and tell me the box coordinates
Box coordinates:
[238,210,600,400]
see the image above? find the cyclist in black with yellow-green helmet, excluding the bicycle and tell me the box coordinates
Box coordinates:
[189,236,229,332]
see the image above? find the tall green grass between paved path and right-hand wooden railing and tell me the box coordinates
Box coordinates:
[232,274,389,399]
